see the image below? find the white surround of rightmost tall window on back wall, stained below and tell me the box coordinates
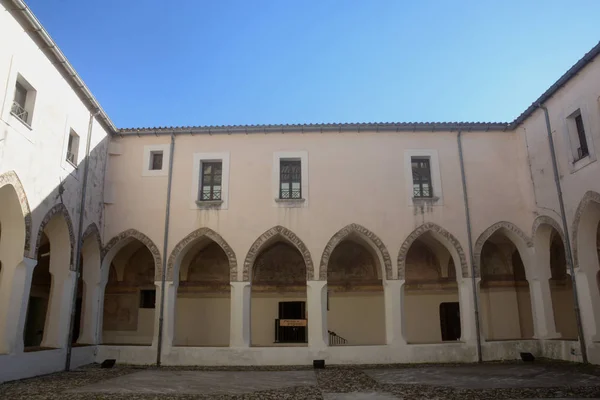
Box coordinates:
[404,149,444,207]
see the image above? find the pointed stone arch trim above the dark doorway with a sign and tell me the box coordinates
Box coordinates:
[243,225,315,282]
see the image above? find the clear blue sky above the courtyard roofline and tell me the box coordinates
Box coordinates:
[28,0,600,128]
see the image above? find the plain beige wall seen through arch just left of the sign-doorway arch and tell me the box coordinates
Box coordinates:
[173,293,231,346]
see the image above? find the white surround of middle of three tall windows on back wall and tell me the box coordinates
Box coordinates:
[271,150,309,208]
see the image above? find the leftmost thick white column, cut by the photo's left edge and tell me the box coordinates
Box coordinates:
[0,258,37,354]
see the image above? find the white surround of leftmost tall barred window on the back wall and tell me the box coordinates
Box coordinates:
[190,152,229,210]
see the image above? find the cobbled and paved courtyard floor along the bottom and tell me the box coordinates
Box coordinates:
[0,362,600,400]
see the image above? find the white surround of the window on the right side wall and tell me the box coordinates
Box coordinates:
[563,105,596,174]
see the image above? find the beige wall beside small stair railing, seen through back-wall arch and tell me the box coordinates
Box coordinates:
[327,292,385,346]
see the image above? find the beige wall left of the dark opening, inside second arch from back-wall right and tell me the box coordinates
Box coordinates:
[404,290,458,343]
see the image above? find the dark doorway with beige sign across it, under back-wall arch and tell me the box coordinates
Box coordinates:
[275,301,306,343]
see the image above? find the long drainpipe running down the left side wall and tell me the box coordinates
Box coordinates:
[65,111,98,371]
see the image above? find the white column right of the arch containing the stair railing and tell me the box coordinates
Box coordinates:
[383,279,406,346]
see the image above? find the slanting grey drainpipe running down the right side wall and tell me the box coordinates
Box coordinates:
[538,104,588,364]
